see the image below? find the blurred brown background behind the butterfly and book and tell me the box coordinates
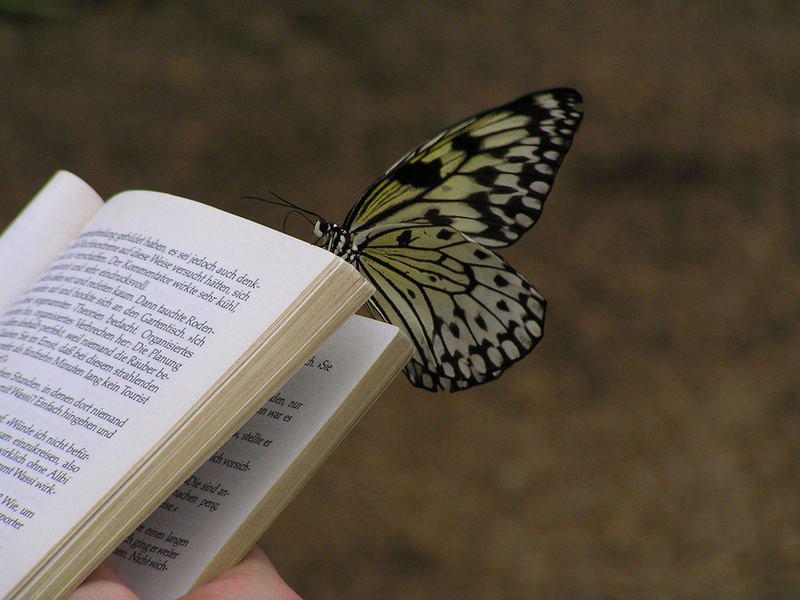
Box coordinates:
[0,0,800,600]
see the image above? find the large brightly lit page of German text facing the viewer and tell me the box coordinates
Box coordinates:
[0,192,348,596]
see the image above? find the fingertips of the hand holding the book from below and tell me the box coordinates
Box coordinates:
[67,546,301,600]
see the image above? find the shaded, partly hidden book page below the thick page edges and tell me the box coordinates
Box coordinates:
[113,316,408,600]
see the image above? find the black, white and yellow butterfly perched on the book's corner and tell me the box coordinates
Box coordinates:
[314,88,582,391]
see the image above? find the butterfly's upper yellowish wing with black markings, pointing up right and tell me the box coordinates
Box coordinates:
[342,88,582,247]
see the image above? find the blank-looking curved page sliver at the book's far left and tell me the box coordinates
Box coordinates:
[0,171,103,314]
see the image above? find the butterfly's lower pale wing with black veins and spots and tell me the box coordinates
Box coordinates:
[356,224,545,391]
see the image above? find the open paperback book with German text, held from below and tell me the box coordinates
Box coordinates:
[0,172,409,599]
